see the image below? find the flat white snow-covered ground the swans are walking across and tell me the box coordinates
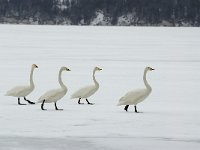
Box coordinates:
[0,25,200,150]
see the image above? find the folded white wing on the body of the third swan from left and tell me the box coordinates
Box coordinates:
[71,85,98,99]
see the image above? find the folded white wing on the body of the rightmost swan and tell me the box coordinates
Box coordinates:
[117,89,147,106]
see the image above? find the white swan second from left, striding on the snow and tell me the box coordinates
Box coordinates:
[37,67,71,110]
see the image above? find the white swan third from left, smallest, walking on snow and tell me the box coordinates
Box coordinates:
[71,67,102,105]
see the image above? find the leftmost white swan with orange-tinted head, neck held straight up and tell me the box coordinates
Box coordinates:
[5,64,38,105]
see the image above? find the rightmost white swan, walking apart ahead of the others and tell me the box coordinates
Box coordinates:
[117,67,155,113]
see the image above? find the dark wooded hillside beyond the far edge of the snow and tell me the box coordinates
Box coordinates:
[0,0,200,26]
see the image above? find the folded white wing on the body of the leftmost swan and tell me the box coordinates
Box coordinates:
[6,86,30,97]
